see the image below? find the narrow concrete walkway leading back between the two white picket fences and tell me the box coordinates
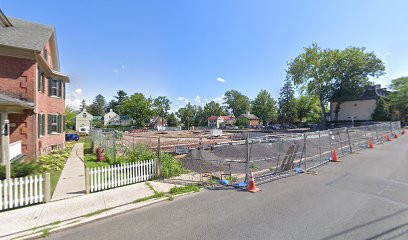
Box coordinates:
[51,143,85,201]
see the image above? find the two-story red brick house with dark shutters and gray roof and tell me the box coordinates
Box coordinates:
[0,10,69,164]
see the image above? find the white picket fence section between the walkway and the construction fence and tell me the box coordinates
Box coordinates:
[86,160,156,192]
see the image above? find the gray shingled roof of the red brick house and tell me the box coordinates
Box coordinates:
[0,17,54,51]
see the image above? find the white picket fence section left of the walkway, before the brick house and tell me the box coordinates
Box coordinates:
[0,175,46,210]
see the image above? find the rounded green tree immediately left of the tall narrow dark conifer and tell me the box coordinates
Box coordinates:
[252,90,278,125]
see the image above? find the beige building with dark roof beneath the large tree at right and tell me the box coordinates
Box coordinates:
[330,85,388,121]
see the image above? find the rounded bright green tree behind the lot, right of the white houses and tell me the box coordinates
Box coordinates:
[120,93,153,127]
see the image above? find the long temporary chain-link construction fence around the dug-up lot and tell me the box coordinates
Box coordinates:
[92,122,401,186]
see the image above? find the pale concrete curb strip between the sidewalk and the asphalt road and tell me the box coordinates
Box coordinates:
[11,189,203,240]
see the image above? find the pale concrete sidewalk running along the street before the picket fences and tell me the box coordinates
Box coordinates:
[0,182,175,239]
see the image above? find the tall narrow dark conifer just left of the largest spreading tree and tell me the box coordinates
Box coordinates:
[278,79,296,123]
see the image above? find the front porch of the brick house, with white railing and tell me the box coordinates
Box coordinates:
[0,93,35,165]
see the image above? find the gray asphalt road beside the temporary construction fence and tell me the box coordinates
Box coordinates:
[50,136,408,240]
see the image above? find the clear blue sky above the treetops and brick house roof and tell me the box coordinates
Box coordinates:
[1,0,408,110]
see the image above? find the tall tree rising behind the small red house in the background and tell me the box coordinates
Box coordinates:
[224,90,251,117]
